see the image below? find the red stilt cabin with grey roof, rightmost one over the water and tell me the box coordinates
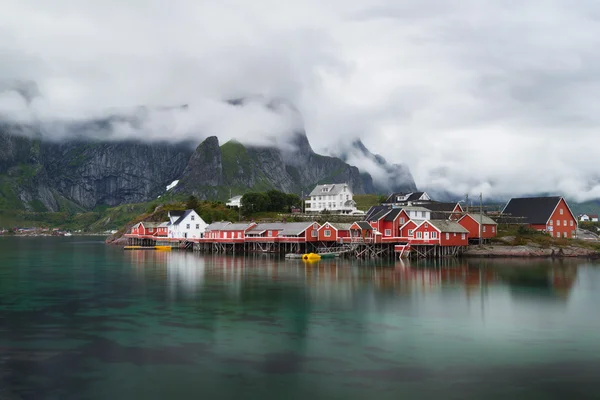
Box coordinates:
[410,219,469,246]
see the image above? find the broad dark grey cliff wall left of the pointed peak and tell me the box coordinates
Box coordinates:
[0,126,193,211]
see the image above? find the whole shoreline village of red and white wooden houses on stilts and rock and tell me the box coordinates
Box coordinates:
[107,184,600,258]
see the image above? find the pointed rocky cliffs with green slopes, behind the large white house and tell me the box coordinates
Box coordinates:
[176,133,373,198]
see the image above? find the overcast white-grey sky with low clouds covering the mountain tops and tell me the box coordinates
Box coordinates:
[0,0,600,201]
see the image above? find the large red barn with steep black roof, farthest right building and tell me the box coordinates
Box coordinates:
[502,196,577,238]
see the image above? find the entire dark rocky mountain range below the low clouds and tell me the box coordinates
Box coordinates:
[0,120,414,211]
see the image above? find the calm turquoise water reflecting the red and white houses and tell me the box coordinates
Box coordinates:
[0,237,600,399]
